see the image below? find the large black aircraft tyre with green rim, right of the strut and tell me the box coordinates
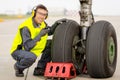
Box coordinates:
[86,21,117,78]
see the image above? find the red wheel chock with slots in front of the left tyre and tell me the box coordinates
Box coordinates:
[44,62,76,80]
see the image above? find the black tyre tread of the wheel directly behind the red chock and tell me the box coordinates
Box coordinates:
[51,20,79,62]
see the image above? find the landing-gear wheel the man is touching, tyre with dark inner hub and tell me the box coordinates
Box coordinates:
[51,20,85,75]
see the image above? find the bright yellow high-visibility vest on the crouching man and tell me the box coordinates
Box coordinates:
[10,17,48,56]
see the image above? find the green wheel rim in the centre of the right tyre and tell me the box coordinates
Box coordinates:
[108,37,115,64]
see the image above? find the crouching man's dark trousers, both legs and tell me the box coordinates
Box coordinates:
[12,40,51,70]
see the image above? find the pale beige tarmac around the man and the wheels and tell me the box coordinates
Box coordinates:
[0,16,120,80]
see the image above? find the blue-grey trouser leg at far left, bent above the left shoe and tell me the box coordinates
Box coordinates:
[12,50,37,70]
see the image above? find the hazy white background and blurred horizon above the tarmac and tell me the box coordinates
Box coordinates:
[0,0,120,19]
